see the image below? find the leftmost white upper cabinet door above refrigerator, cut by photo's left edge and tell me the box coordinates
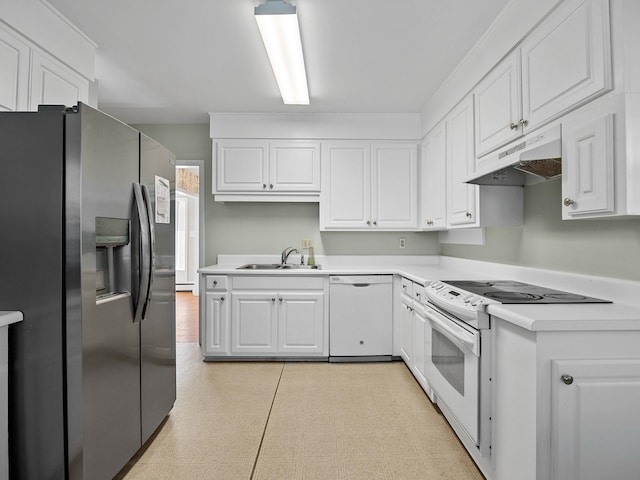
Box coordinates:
[0,29,29,112]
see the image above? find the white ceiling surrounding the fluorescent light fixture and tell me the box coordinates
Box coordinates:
[50,0,509,123]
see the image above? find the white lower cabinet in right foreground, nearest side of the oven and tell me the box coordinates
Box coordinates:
[491,317,640,480]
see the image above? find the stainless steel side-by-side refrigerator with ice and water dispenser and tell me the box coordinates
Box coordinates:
[0,104,176,480]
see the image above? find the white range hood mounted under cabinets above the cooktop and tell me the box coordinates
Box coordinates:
[465,125,562,186]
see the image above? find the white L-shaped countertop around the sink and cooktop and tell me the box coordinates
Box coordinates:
[199,255,640,331]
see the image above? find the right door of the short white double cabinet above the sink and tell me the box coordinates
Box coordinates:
[269,141,320,192]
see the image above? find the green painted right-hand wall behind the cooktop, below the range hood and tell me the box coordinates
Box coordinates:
[442,180,640,282]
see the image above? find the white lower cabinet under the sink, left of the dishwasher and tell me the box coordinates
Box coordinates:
[201,276,329,359]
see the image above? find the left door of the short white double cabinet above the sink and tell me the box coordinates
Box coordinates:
[213,140,273,193]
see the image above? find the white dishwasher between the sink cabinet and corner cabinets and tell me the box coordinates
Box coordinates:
[329,275,393,362]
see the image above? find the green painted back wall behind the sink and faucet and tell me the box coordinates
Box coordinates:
[135,125,440,265]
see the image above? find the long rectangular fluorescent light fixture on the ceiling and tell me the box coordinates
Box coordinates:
[255,0,309,105]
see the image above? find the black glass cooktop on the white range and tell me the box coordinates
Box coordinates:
[444,280,611,303]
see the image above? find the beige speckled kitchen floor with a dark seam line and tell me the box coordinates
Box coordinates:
[117,343,483,480]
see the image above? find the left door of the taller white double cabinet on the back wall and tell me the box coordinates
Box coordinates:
[320,143,372,230]
